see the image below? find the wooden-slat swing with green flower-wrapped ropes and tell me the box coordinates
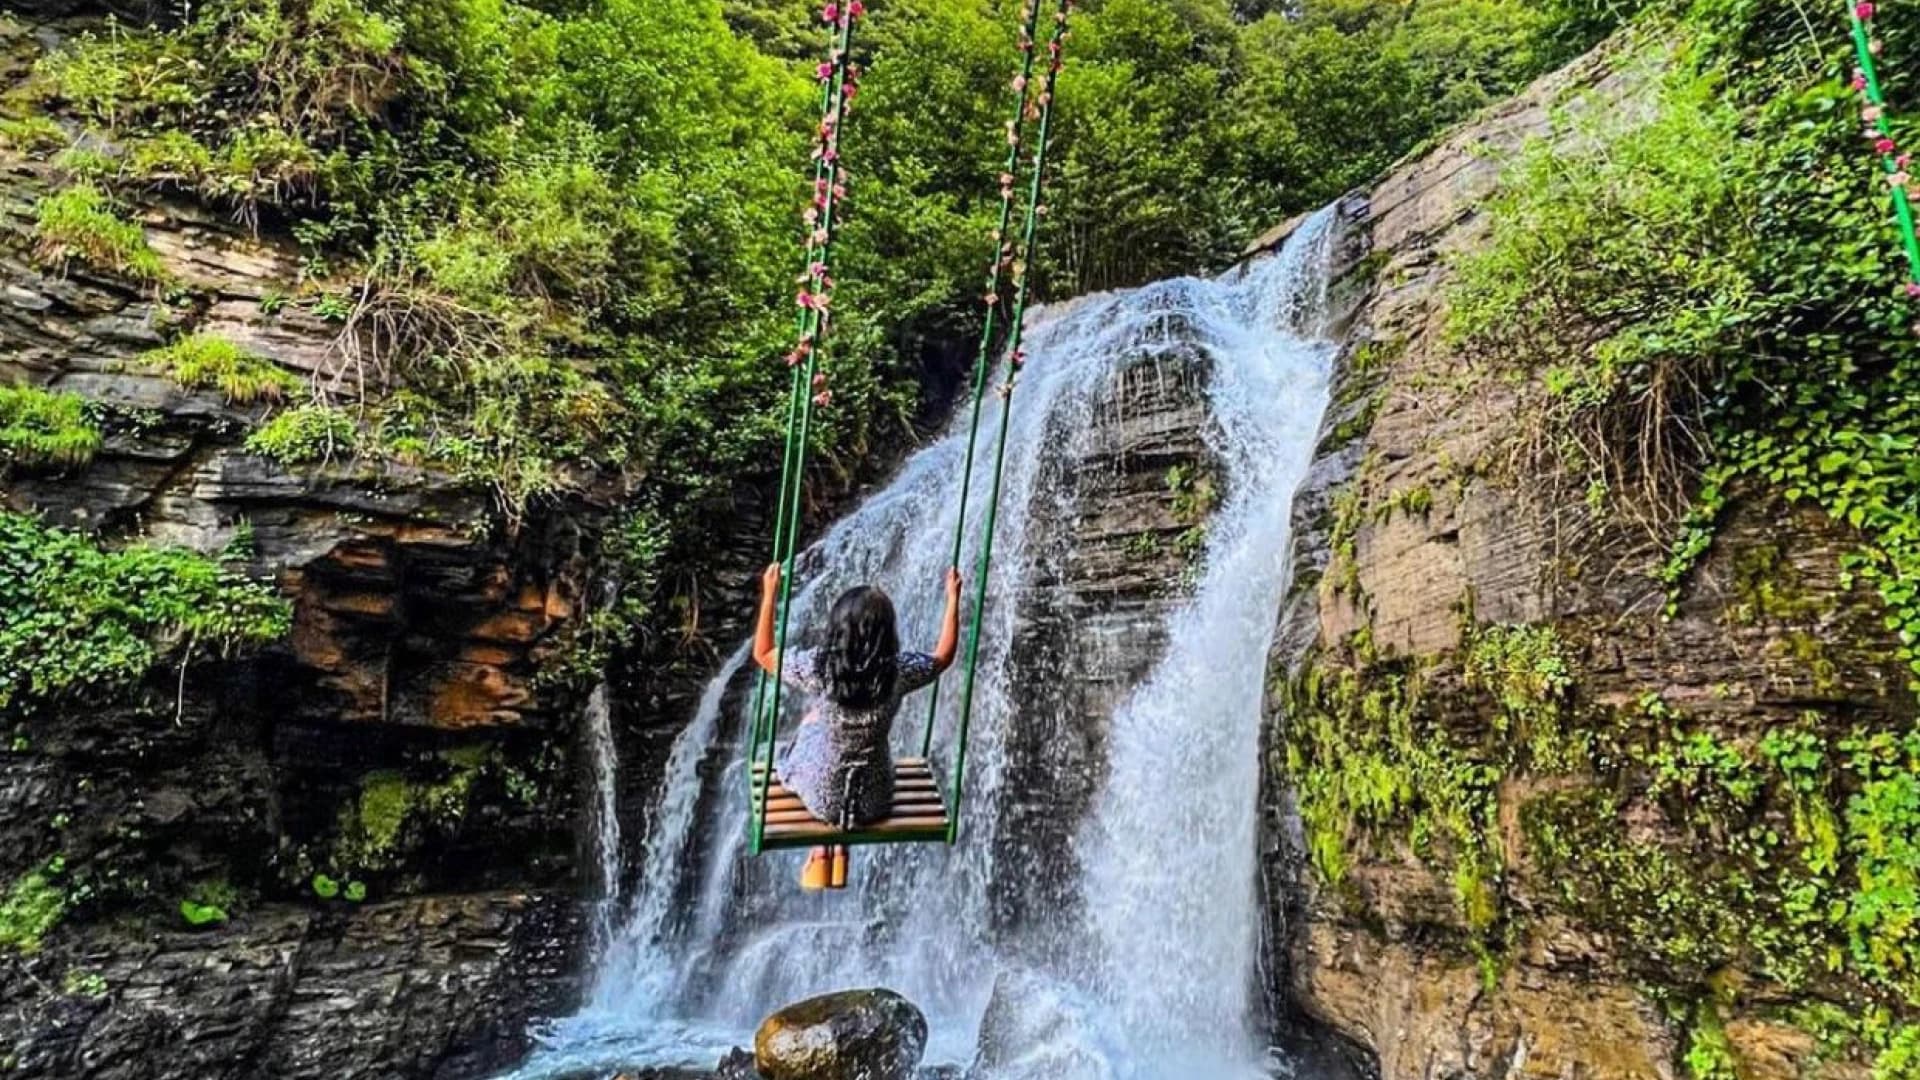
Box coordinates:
[747,0,1071,855]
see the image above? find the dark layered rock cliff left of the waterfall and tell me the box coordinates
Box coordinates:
[0,6,595,1078]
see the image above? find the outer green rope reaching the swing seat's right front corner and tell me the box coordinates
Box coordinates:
[927,0,1073,844]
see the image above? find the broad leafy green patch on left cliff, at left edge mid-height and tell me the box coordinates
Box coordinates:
[0,513,292,711]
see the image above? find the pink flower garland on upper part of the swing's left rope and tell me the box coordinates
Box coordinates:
[785,0,866,407]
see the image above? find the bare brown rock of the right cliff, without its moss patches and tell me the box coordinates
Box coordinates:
[1261,23,1912,1080]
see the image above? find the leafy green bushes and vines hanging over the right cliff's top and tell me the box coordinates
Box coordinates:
[1455,8,1920,688]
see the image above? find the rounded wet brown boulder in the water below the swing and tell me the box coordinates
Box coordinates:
[753,990,927,1080]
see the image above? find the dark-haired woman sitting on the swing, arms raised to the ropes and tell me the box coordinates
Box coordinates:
[753,563,960,890]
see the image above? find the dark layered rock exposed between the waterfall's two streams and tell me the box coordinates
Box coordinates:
[995,342,1217,933]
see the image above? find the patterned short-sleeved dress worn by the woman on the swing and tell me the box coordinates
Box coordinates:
[780,650,939,824]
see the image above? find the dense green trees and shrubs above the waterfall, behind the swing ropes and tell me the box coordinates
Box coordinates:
[15,0,1611,542]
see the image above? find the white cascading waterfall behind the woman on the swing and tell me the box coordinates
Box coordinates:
[520,211,1332,1080]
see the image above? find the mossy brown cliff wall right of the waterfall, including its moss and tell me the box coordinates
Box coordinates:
[1265,37,1920,1080]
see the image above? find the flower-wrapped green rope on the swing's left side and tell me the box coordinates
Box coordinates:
[747,0,860,855]
